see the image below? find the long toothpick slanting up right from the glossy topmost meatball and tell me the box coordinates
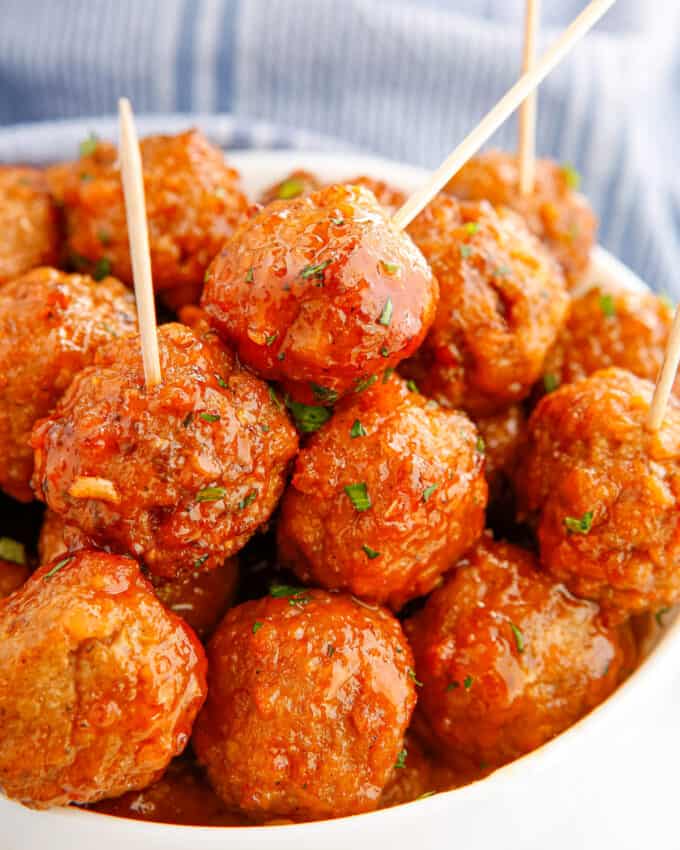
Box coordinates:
[392,0,616,229]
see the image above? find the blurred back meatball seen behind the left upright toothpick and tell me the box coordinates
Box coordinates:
[48,130,248,298]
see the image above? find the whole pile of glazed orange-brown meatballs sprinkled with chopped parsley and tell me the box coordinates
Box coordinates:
[0,136,680,825]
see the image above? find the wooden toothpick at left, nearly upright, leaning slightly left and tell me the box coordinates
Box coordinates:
[118,97,162,387]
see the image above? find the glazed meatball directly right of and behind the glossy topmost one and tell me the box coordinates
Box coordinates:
[405,195,568,416]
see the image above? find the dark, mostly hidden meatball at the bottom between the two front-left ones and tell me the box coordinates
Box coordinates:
[92,756,246,826]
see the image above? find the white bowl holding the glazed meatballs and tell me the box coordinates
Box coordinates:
[0,147,680,850]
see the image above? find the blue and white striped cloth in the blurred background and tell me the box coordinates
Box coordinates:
[0,0,680,295]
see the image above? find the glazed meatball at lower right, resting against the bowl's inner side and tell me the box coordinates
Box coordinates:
[405,537,631,771]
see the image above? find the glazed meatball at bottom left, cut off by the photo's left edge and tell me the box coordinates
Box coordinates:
[0,550,206,807]
